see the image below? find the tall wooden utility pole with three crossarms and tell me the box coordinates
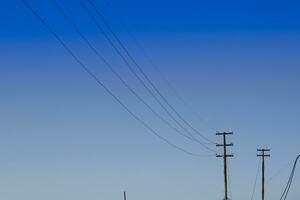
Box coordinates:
[216,132,234,200]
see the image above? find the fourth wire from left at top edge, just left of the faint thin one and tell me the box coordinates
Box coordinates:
[84,0,215,144]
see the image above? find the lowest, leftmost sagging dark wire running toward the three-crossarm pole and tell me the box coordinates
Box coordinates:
[21,0,210,157]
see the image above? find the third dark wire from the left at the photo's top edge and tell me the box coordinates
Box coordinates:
[81,1,217,153]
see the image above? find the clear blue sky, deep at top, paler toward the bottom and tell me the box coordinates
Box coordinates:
[0,0,300,200]
